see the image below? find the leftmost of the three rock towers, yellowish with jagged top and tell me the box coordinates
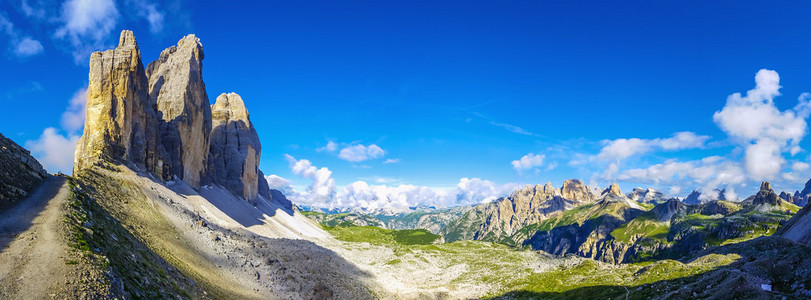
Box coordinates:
[74,30,164,176]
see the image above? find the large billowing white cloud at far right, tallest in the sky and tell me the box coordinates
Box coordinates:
[713,69,811,180]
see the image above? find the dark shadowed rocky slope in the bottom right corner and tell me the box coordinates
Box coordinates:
[493,236,811,299]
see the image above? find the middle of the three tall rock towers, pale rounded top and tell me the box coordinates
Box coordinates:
[146,34,212,187]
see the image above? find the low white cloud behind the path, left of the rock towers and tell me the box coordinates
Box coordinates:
[25,127,79,174]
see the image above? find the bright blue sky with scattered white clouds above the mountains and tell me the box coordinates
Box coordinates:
[0,0,811,210]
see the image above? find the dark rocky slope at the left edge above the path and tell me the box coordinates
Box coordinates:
[0,133,49,210]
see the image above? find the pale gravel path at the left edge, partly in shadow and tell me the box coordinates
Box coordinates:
[0,177,70,299]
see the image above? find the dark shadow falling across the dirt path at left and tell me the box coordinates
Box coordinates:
[0,176,67,253]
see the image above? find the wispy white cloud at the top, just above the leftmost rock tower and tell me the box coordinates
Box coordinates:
[54,0,119,63]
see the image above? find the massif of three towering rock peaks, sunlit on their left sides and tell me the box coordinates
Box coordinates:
[74,30,278,206]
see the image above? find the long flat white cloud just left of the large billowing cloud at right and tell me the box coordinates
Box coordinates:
[596,131,710,161]
